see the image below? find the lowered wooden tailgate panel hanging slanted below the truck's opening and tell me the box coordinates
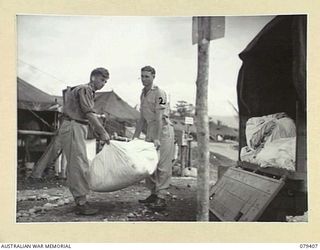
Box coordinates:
[210,167,285,221]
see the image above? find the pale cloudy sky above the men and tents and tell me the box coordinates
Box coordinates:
[17,15,274,116]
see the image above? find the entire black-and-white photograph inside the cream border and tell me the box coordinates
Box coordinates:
[12,13,309,224]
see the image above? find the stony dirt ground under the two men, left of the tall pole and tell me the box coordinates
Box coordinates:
[17,177,200,222]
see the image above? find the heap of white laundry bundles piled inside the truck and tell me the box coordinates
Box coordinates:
[240,113,296,171]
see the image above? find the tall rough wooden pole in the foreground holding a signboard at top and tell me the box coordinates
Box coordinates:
[196,17,210,221]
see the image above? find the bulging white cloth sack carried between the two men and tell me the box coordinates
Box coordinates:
[88,139,159,192]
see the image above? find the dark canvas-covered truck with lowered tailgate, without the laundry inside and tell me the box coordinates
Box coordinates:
[210,15,308,221]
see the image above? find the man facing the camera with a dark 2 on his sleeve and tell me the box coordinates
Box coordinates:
[133,66,174,210]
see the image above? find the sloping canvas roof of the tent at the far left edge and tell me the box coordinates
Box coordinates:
[17,77,56,111]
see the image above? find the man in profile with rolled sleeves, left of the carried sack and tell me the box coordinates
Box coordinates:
[58,68,110,215]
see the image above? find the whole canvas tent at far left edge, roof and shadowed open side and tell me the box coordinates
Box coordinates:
[17,77,60,162]
